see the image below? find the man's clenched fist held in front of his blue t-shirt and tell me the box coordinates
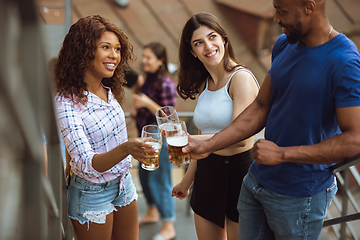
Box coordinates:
[252,139,283,165]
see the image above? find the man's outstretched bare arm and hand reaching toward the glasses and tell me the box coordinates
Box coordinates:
[183,73,272,159]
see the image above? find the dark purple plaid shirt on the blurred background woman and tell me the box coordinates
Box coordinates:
[136,74,177,135]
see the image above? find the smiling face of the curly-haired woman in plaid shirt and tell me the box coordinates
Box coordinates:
[86,31,121,79]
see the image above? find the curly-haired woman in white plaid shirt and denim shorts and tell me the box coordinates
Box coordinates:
[55,15,157,240]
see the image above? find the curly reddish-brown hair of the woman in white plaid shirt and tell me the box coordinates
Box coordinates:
[55,15,135,104]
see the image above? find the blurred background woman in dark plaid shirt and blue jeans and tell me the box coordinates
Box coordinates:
[133,42,177,240]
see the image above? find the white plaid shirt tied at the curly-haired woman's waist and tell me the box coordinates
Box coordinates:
[56,88,132,183]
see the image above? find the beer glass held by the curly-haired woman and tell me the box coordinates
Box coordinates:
[141,125,162,171]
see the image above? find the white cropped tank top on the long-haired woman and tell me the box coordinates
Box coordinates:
[194,68,259,134]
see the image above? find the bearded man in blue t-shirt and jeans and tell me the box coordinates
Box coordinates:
[183,0,360,240]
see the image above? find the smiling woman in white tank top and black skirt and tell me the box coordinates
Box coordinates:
[172,13,259,240]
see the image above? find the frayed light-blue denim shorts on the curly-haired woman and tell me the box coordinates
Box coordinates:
[67,172,138,224]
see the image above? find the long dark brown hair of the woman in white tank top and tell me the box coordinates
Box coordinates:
[176,12,241,99]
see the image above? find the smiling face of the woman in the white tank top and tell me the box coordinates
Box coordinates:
[191,25,225,66]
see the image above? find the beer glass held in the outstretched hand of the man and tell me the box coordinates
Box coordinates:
[165,121,190,167]
